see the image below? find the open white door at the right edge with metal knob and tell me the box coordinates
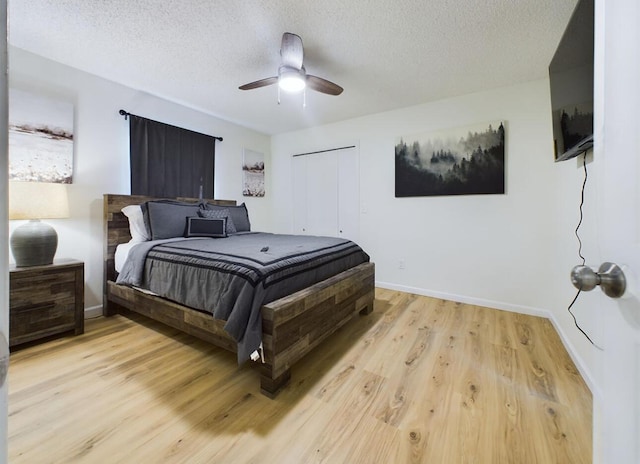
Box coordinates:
[583,0,640,464]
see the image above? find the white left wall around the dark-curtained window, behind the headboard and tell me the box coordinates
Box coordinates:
[9,47,270,308]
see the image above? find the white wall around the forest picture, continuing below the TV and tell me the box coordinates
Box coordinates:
[271,79,604,388]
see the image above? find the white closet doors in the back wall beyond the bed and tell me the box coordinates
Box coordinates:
[293,148,359,240]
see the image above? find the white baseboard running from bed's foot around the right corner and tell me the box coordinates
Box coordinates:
[376,281,600,396]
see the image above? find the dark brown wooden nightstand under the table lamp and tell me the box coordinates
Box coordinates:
[9,259,84,347]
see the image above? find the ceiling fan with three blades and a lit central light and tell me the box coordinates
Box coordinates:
[239,32,343,95]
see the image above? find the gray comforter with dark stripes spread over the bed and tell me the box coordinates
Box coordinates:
[117,232,369,363]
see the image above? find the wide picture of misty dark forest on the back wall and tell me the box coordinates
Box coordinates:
[395,121,505,197]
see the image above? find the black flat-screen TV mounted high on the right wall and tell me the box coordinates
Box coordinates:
[549,0,594,161]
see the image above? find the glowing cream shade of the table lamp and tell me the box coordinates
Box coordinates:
[9,181,69,219]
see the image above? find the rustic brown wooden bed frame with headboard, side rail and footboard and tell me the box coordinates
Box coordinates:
[103,194,375,398]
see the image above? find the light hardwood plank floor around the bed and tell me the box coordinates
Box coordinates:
[9,289,592,464]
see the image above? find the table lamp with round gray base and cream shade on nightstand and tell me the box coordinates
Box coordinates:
[9,181,69,267]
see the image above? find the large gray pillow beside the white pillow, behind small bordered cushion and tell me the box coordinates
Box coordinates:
[142,200,200,240]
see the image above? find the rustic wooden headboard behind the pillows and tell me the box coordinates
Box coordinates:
[103,193,236,286]
